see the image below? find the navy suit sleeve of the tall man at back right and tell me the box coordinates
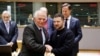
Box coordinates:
[74,20,82,44]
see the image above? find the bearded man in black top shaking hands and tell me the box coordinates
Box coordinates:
[49,14,74,56]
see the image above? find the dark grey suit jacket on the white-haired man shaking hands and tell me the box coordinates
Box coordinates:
[19,23,48,56]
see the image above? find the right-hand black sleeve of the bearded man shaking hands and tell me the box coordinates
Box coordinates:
[52,31,74,55]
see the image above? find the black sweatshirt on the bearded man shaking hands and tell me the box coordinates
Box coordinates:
[49,28,74,56]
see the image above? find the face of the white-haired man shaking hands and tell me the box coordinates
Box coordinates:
[34,13,47,28]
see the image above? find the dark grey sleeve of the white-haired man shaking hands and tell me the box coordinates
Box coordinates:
[23,26,46,53]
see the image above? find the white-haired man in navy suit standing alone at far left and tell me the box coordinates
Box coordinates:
[0,11,18,51]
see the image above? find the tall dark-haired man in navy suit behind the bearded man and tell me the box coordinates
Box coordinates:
[62,3,82,56]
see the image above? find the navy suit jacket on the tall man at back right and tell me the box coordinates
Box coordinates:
[69,16,82,52]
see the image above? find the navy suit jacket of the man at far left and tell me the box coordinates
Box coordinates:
[0,20,18,51]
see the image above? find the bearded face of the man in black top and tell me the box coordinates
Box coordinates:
[53,17,64,30]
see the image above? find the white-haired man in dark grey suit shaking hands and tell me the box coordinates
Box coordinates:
[19,10,51,56]
